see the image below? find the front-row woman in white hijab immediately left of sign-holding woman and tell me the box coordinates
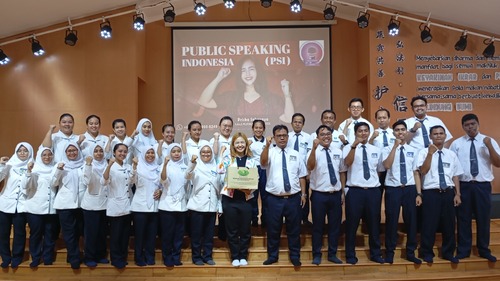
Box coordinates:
[187,141,221,265]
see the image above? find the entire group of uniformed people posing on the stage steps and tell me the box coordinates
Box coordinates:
[0,96,500,269]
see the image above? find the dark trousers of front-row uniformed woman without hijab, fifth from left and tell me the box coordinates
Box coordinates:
[108,215,130,267]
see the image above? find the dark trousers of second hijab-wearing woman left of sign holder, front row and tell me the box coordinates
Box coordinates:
[159,210,187,266]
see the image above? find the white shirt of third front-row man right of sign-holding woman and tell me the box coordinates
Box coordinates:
[343,143,384,188]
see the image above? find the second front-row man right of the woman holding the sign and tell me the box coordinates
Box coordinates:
[307,125,346,265]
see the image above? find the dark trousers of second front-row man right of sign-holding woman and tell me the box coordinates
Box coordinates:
[311,190,342,258]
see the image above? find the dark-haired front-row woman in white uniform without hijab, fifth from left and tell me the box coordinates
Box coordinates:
[102,143,137,269]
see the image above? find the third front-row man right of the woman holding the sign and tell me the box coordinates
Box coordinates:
[343,122,384,264]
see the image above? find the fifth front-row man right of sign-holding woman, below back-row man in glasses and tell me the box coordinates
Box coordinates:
[416,125,463,263]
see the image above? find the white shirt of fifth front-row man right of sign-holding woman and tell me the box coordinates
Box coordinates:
[417,148,463,190]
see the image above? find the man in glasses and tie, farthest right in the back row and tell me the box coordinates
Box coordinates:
[405,96,453,150]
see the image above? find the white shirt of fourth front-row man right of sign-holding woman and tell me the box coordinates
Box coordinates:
[382,144,418,187]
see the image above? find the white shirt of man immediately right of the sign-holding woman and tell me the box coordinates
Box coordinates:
[263,146,307,196]
